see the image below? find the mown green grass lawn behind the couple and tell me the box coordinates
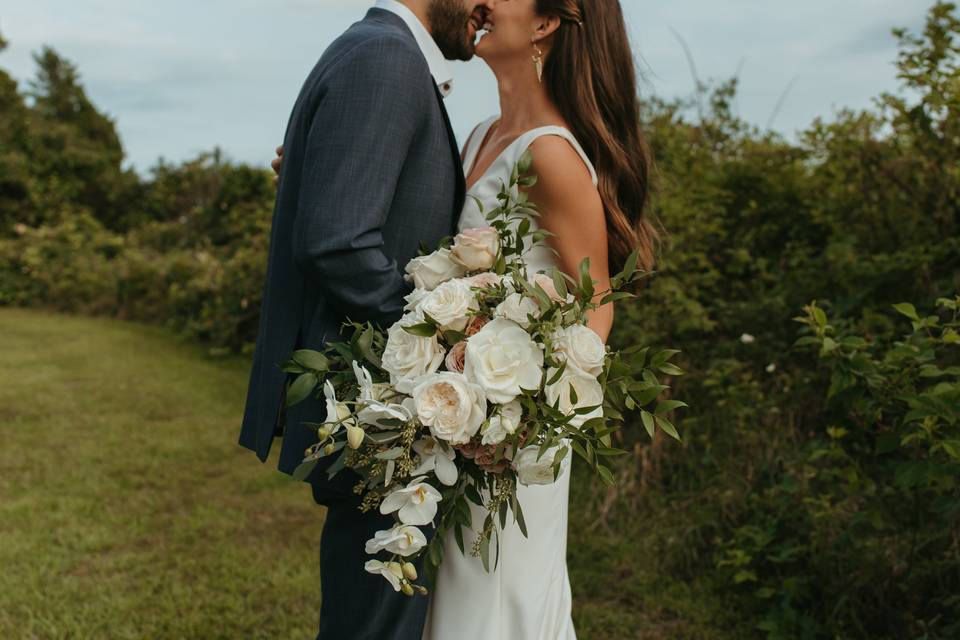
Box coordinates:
[0,309,733,640]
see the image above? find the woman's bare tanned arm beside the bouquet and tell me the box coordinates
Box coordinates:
[529,136,613,341]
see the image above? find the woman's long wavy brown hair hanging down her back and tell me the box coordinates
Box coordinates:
[536,0,659,273]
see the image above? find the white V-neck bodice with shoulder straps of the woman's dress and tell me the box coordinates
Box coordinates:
[457,116,597,274]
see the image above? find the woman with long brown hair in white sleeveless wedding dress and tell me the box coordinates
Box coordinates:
[274,0,657,640]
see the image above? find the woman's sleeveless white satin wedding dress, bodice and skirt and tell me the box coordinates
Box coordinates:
[423,117,597,640]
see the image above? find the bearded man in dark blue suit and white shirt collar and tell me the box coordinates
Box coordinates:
[240,0,487,640]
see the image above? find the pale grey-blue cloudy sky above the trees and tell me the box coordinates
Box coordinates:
[0,0,932,170]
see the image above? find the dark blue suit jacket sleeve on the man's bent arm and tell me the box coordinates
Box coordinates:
[293,39,435,326]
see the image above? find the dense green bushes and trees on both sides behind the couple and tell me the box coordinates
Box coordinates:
[0,2,960,639]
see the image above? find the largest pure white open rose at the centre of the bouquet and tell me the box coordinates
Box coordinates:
[463,318,543,404]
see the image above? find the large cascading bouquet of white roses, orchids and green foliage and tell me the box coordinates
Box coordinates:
[283,156,686,595]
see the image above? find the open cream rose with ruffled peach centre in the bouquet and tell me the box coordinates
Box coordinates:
[413,371,487,444]
